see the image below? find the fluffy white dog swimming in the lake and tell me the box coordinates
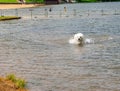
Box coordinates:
[69,33,85,45]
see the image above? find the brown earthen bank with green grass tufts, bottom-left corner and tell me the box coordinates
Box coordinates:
[0,74,28,91]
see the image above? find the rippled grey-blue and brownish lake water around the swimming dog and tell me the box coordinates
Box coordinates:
[0,2,120,91]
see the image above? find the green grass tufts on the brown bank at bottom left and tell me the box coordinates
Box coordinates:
[6,74,26,88]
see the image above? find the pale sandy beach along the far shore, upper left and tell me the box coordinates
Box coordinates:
[0,4,44,9]
